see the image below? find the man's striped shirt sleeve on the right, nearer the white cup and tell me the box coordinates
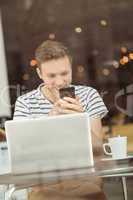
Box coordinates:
[86,88,108,118]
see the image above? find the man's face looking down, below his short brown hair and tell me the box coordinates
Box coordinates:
[37,56,72,89]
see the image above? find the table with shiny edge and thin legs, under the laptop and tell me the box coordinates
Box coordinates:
[0,141,133,200]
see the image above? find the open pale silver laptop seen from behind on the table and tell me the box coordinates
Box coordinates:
[5,113,94,174]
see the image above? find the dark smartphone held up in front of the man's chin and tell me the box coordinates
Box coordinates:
[59,87,75,99]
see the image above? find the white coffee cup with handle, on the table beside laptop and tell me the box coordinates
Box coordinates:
[103,136,127,159]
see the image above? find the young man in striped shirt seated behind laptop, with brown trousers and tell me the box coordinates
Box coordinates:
[14,41,107,200]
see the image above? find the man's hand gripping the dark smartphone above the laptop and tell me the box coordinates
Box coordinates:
[49,97,84,116]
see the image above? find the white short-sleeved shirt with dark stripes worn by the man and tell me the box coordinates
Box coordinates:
[14,84,108,119]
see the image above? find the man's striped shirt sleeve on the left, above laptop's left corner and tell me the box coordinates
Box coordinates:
[13,97,30,120]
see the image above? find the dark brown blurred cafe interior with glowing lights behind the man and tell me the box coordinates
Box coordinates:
[0,0,133,200]
